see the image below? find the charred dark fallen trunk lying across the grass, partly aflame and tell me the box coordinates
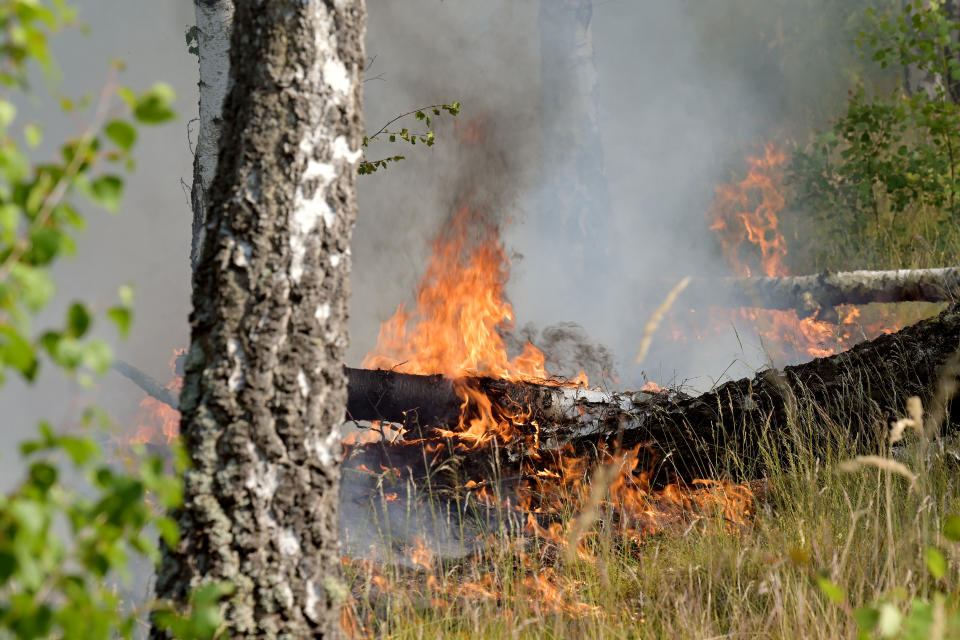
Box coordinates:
[114,306,960,481]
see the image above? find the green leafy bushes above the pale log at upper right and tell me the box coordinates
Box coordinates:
[792,0,960,267]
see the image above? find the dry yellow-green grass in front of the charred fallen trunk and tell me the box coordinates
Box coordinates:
[348,382,960,639]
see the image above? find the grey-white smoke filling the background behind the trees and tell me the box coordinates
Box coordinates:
[0,0,888,486]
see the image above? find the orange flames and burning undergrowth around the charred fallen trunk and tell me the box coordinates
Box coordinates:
[341,207,754,633]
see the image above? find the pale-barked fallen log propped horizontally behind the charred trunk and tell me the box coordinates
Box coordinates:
[687,267,960,314]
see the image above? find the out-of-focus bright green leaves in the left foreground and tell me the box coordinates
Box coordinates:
[0,0,219,640]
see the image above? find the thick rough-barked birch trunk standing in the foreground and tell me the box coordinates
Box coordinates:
[152,0,365,638]
